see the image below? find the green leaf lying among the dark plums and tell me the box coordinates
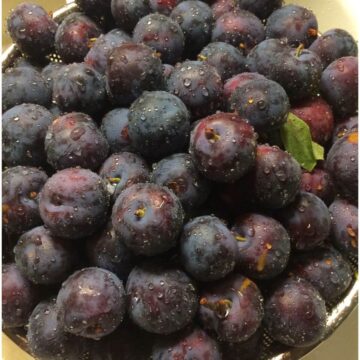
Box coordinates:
[280,113,324,171]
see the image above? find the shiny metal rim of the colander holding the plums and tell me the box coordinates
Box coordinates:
[1,3,359,360]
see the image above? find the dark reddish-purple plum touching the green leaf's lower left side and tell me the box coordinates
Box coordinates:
[253,145,301,209]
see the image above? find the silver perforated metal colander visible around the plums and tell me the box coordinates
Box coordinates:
[1,3,359,360]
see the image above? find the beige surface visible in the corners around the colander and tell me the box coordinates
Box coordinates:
[2,0,359,360]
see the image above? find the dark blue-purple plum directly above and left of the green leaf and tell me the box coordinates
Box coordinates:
[229,79,290,134]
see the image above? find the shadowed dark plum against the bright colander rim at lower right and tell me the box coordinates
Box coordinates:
[289,247,353,304]
